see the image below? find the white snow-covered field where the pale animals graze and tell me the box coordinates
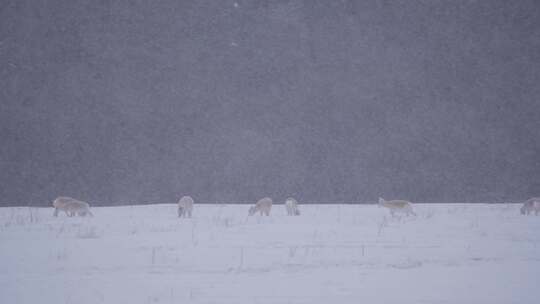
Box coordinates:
[0,204,540,304]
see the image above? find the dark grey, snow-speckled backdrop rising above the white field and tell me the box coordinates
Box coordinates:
[0,0,540,205]
